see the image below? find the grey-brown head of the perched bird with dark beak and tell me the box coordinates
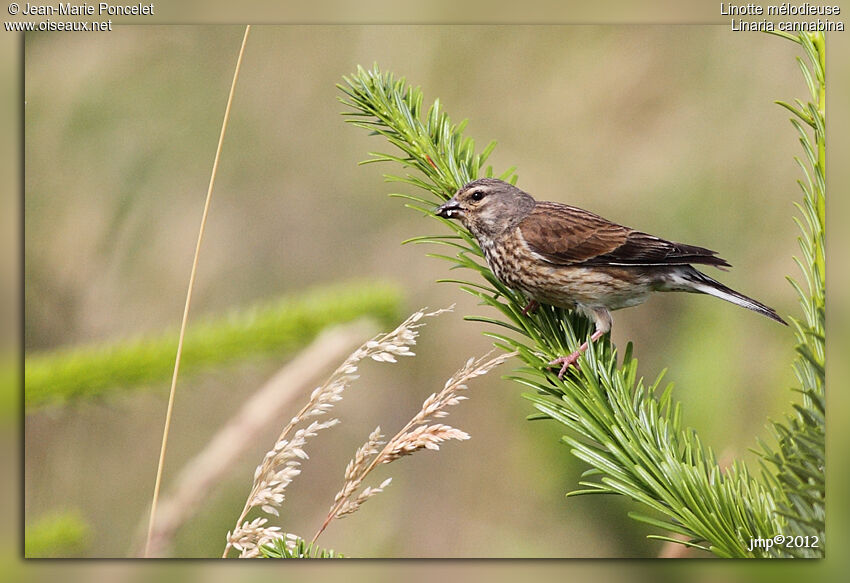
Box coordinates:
[434,178,535,237]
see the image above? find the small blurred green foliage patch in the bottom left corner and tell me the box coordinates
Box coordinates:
[24,512,89,559]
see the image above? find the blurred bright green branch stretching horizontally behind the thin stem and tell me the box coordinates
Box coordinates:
[24,281,400,413]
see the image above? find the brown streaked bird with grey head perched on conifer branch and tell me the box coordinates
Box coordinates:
[434,178,788,379]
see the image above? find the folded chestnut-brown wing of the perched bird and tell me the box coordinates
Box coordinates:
[519,202,729,267]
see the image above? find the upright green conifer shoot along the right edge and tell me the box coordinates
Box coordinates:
[763,33,826,557]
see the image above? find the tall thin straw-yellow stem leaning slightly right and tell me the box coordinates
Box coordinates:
[144,24,251,557]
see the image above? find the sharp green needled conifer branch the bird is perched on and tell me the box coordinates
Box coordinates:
[339,46,820,557]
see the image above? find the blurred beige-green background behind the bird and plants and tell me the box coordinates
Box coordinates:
[24,26,806,557]
